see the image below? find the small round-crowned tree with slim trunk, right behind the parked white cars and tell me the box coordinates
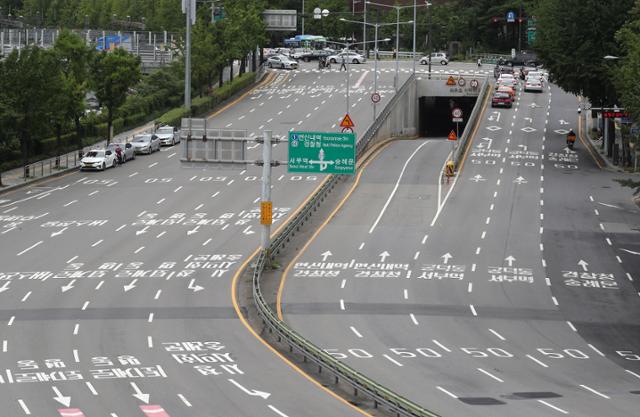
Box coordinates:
[90,48,140,143]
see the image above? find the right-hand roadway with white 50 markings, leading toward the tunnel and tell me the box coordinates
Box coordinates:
[281,75,640,417]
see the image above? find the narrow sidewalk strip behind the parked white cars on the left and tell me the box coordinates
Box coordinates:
[0,61,245,194]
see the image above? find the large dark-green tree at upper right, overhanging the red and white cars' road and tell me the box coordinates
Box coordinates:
[535,0,634,104]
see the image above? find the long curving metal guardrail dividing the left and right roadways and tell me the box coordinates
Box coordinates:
[253,76,438,417]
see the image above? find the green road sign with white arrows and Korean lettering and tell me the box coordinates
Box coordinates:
[288,132,356,174]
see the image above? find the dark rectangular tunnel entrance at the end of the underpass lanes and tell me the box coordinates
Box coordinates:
[418,96,477,138]
